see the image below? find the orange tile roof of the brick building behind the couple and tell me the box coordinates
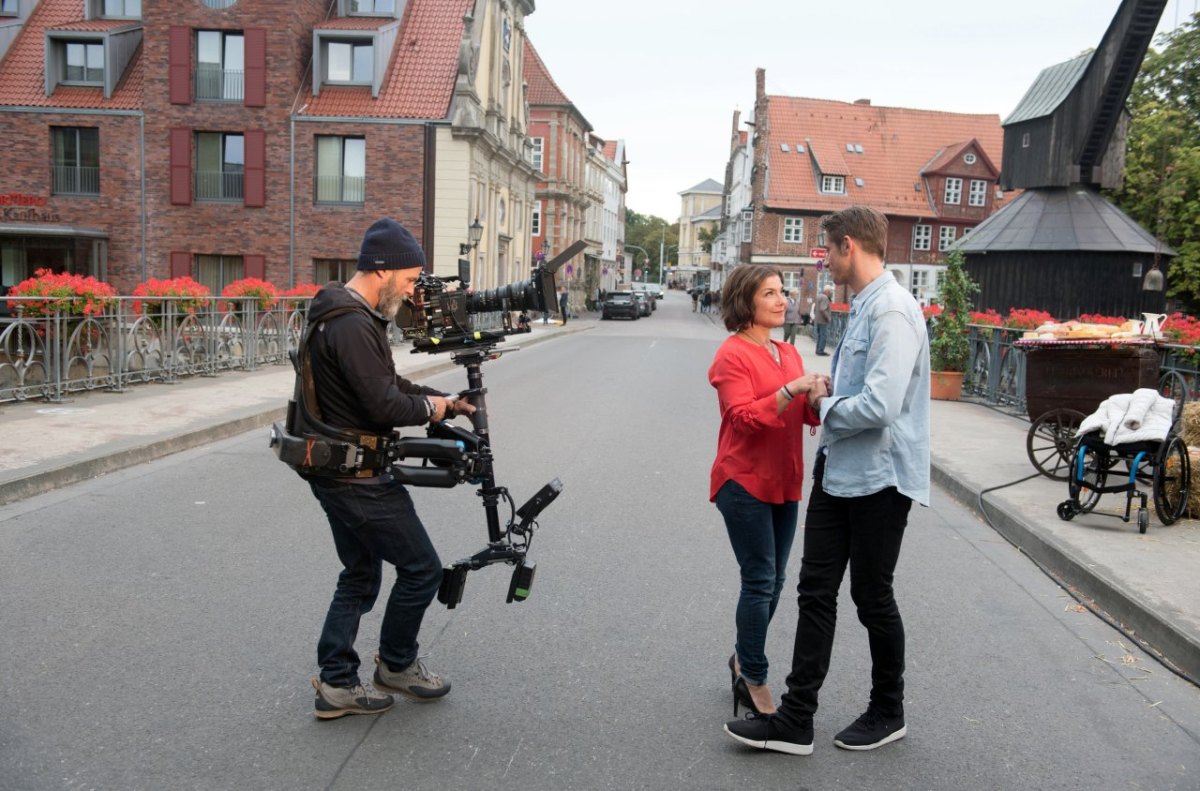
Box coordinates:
[767,96,1012,217]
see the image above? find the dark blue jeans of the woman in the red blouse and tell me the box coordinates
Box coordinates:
[716,480,799,684]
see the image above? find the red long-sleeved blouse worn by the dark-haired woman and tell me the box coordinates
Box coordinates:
[708,335,821,503]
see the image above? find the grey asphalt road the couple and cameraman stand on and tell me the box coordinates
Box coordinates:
[0,294,1200,790]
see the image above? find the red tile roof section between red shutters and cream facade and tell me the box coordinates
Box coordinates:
[301,0,475,119]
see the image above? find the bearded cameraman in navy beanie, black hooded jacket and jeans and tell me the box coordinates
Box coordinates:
[307,218,475,719]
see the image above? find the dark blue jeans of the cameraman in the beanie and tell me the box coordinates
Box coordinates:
[308,479,442,687]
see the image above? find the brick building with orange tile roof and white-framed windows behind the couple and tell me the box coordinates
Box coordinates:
[724,68,1015,304]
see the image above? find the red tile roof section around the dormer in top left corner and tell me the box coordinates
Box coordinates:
[0,0,143,110]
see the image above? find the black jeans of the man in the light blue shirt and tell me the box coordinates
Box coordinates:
[779,455,912,724]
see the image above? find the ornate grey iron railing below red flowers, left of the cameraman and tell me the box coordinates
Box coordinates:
[0,296,308,403]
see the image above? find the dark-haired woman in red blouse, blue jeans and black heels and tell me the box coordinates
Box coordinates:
[708,264,828,717]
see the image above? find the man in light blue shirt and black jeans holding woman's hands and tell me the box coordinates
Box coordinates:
[725,206,929,755]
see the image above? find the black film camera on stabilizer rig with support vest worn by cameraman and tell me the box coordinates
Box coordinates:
[270,241,584,610]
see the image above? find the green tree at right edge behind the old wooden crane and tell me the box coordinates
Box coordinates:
[1110,14,1200,311]
